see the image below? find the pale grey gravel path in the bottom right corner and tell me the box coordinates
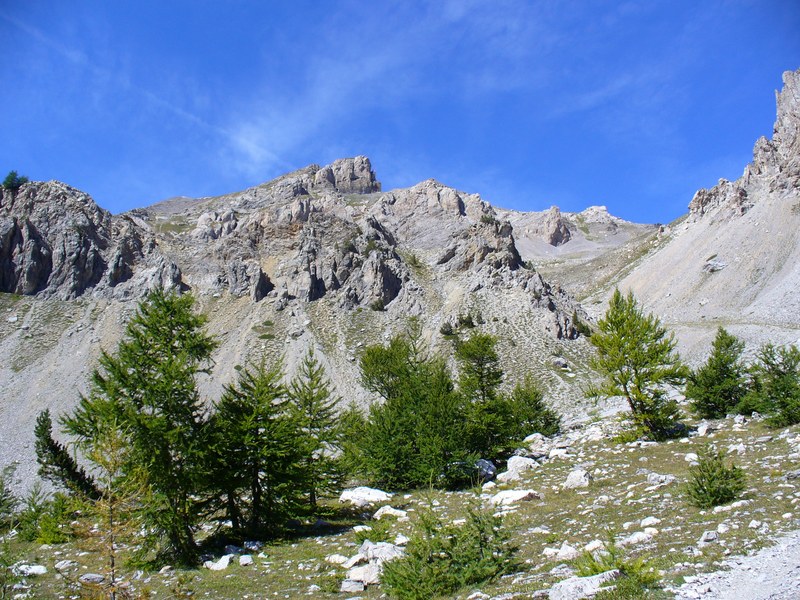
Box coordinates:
[673,531,800,600]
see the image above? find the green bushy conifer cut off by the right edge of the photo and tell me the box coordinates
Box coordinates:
[739,344,800,427]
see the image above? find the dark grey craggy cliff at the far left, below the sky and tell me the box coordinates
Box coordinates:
[0,181,181,300]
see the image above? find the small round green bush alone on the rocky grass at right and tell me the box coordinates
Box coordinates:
[686,450,745,508]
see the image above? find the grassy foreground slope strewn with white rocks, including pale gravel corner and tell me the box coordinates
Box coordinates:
[4,400,800,600]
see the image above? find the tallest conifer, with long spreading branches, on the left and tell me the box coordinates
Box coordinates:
[62,289,216,564]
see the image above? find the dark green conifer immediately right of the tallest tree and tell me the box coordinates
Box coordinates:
[212,361,303,534]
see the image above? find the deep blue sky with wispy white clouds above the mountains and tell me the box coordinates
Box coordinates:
[0,0,800,223]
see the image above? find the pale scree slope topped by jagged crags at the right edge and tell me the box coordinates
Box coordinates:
[604,71,800,360]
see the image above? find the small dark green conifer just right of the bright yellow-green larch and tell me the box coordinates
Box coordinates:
[686,327,747,419]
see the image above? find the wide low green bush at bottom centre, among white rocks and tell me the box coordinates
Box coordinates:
[381,507,517,600]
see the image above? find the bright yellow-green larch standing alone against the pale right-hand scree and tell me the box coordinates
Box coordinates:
[589,290,688,439]
